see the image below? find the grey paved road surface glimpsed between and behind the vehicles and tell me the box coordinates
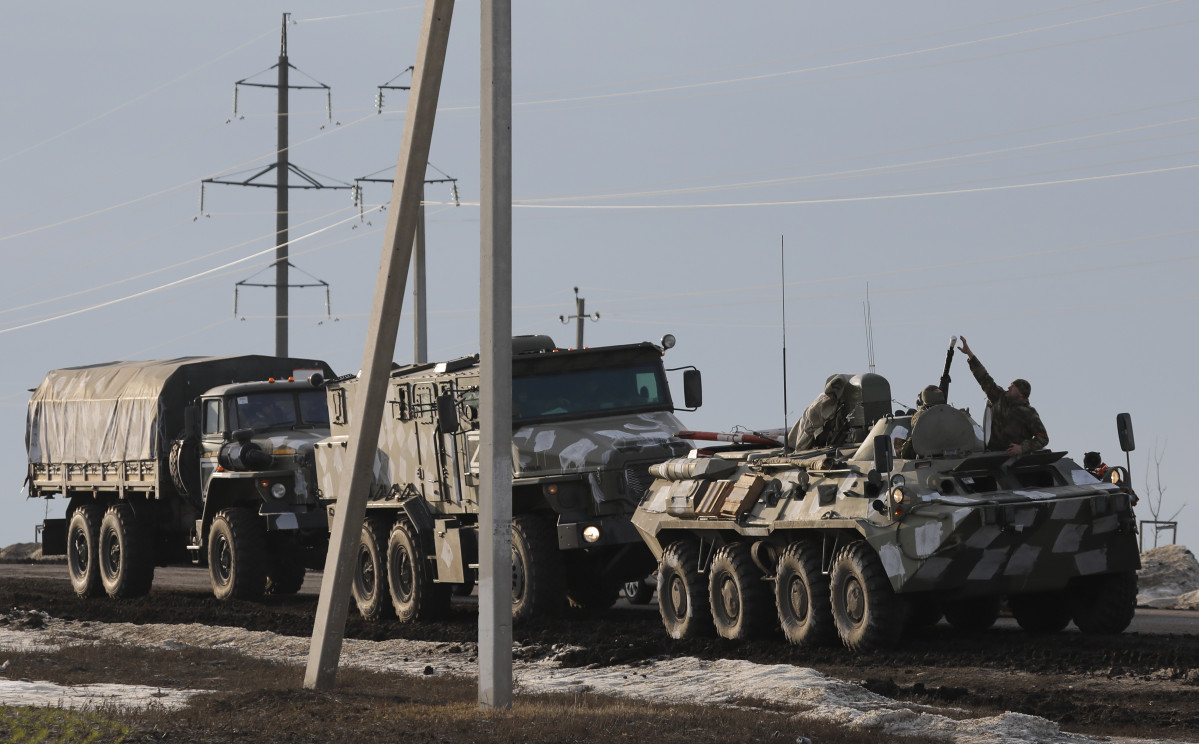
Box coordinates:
[0,563,1199,635]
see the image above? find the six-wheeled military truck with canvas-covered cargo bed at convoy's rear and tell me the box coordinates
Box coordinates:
[25,356,332,599]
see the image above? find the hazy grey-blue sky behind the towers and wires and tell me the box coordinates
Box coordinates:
[0,0,1199,544]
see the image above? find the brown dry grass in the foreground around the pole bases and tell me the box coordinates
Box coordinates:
[0,645,938,744]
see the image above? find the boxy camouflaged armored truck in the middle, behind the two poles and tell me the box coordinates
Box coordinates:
[317,335,701,622]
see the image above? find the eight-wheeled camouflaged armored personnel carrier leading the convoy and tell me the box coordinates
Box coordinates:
[633,374,1140,651]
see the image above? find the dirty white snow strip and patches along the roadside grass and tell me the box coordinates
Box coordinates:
[0,618,1189,744]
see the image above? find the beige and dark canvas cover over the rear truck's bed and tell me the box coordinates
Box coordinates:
[25,356,333,464]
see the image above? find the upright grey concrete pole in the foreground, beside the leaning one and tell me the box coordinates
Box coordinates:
[478,0,512,708]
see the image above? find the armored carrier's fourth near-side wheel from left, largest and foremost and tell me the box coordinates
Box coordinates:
[829,540,903,651]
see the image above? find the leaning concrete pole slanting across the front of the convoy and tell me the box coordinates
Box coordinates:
[305,0,453,689]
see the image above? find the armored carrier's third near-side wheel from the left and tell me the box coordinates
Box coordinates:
[775,543,837,646]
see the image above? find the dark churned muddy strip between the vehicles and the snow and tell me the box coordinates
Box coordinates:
[0,579,1199,740]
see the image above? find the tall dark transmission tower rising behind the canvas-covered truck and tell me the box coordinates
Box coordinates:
[200,13,353,357]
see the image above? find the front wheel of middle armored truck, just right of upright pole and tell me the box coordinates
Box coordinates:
[512,514,566,623]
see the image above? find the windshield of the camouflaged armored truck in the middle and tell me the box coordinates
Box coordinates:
[512,364,671,421]
